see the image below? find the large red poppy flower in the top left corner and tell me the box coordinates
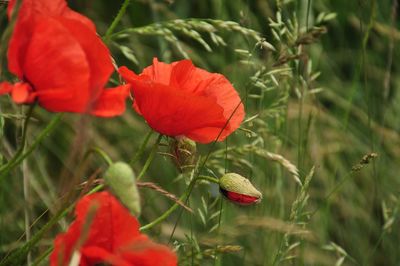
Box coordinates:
[0,0,129,117]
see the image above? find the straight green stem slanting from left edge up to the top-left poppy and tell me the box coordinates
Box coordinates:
[0,113,62,180]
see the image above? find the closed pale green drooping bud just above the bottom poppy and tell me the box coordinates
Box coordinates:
[104,162,140,216]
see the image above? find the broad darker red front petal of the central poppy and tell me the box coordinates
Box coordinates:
[132,81,225,136]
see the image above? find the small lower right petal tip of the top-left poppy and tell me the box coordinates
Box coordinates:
[91,84,130,117]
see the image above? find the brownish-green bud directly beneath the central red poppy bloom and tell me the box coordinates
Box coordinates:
[170,137,197,172]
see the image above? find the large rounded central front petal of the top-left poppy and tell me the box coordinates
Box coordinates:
[24,18,90,112]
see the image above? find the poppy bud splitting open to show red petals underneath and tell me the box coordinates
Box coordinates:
[219,173,262,205]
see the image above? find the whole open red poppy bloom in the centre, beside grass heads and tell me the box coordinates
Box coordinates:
[119,58,244,143]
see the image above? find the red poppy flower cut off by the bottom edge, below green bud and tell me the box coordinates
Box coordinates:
[50,192,177,266]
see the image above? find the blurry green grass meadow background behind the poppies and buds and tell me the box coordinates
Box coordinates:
[0,0,400,265]
